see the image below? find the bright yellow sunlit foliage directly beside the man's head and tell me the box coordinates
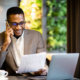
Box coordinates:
[19,0,42,33]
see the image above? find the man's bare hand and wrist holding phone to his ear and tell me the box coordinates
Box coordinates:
[2,26,14,51]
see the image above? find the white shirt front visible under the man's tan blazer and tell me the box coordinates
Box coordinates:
[12,32,24,67]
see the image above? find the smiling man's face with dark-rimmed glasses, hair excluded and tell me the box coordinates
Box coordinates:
[9,14,25,36]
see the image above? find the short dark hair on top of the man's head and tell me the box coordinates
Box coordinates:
[6,7,24,20]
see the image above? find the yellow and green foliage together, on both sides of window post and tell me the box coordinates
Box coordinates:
[19,0,67,51]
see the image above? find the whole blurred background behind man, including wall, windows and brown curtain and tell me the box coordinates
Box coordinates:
[0,0,80,78]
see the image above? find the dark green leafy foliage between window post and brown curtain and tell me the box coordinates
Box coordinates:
[46,0,67,51]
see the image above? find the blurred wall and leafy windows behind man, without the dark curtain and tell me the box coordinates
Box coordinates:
[0,0,67,53]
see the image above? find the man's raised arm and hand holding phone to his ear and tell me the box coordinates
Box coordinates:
[0,25,13,68]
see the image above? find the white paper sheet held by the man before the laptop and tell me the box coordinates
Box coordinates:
[16,52,46,73]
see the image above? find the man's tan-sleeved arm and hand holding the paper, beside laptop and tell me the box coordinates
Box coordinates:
[31,33,48,75]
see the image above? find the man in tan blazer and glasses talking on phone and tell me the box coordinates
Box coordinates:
[0,7,47,75]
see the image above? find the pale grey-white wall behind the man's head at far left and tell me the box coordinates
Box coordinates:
[0,0,18,33]
